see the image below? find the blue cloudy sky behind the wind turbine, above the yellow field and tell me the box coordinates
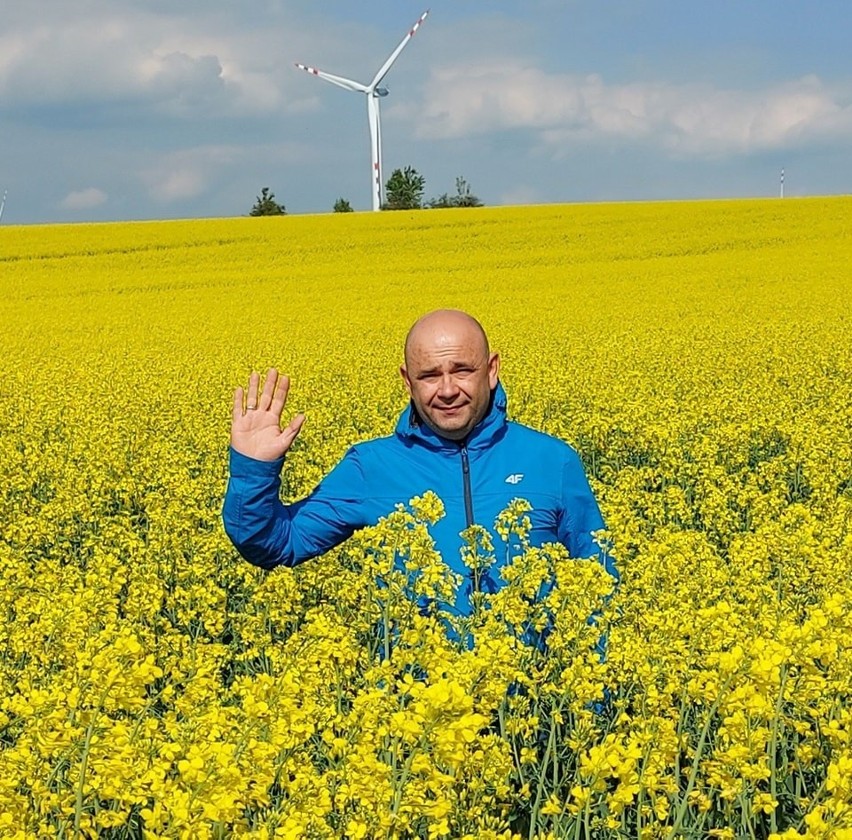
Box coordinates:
[0,0,852,224]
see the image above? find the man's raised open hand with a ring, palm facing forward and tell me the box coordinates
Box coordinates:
[231,368,305,461]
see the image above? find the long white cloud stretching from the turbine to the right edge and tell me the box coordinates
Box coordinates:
[408,62,852,156]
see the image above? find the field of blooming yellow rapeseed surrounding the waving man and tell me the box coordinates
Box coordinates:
[0,198,852,840]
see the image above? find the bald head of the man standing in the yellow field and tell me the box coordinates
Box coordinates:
[400,309,500,440]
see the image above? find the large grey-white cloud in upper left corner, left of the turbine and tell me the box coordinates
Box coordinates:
[0,0,316,117]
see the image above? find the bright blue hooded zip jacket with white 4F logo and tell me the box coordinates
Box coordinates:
[222,383,618,613]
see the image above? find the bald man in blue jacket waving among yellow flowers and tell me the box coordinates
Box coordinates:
[223,310,618,613]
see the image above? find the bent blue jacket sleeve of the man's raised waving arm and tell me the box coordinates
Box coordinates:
[222,447,369,569]
